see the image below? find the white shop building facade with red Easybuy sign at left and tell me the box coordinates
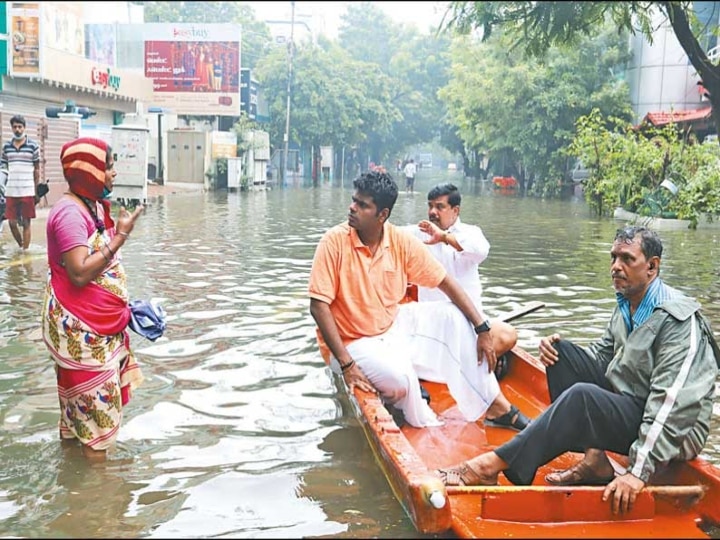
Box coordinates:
[0,2,152,204]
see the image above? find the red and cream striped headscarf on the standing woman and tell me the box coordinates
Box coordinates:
[60,137,108,201]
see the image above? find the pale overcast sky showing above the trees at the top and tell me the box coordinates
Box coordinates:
[247,1,446,38]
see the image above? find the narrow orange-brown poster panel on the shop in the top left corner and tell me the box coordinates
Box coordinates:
[8,2,40,77]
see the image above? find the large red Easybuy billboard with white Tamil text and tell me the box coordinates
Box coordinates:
[143,23,240,116]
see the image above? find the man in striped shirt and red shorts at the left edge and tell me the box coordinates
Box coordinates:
[0,115,40,249]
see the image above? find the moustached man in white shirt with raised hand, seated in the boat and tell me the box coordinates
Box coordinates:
[403,183,517,428]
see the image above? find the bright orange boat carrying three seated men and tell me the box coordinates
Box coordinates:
[350,302,720,538]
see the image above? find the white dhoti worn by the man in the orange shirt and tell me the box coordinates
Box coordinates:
[330,302,500,427]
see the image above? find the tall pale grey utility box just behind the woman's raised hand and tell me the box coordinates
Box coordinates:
[111,124,150,203]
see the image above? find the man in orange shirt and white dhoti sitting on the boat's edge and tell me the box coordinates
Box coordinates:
[309,171,529,430]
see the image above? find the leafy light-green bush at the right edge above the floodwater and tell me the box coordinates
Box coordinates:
[569,110,720,226]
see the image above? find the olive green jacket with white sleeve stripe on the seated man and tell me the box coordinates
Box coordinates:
[585,293,720,482]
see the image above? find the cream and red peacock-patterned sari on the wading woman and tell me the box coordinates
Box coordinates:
[42,217,143,450]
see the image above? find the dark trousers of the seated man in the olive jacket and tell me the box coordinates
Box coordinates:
[495,341,645,485]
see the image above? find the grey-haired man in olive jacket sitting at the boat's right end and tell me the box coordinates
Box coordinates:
[439,227,720,512]
